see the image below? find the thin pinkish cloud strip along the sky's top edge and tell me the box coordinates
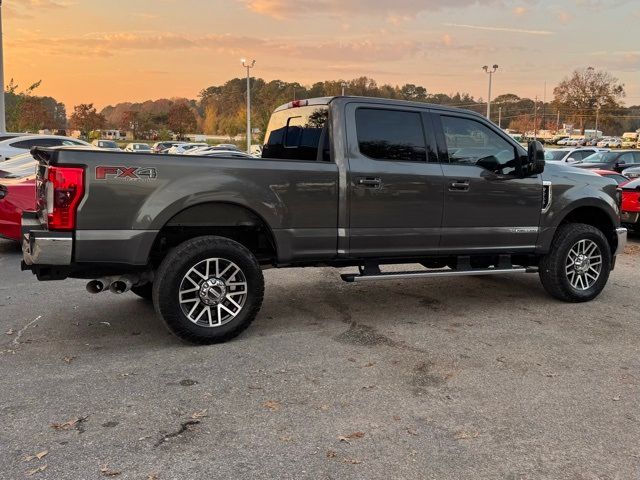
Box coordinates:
[238,0,503,19]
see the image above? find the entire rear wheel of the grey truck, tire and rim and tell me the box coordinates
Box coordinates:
[153,236,264,344]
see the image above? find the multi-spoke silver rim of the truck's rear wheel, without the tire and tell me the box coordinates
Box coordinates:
[178,258,248,327]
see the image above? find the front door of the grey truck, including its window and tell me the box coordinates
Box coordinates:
[434,114,542,253]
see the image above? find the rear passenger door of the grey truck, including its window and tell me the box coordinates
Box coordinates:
[346,103,444,256]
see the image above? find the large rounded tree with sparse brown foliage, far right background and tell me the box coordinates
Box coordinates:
[553,67,625,134]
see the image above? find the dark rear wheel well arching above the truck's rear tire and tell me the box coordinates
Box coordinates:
[149,203,277,267]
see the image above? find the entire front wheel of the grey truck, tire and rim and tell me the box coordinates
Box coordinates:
[540,223,611,302]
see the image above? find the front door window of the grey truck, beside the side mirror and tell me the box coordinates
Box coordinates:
[441,116,516,175]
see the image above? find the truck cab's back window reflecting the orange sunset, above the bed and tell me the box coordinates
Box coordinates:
[262,105,329,160]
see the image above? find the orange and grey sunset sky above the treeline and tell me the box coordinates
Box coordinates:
[2,0,640,111]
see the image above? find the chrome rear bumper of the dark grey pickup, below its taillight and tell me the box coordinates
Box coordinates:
[22,212,73,266]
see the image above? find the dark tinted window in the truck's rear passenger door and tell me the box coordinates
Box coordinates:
[356,108,427,162]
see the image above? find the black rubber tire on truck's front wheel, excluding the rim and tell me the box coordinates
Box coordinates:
[539,223,612,303]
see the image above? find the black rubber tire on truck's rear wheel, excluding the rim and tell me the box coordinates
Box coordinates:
[153,236,264,345]
